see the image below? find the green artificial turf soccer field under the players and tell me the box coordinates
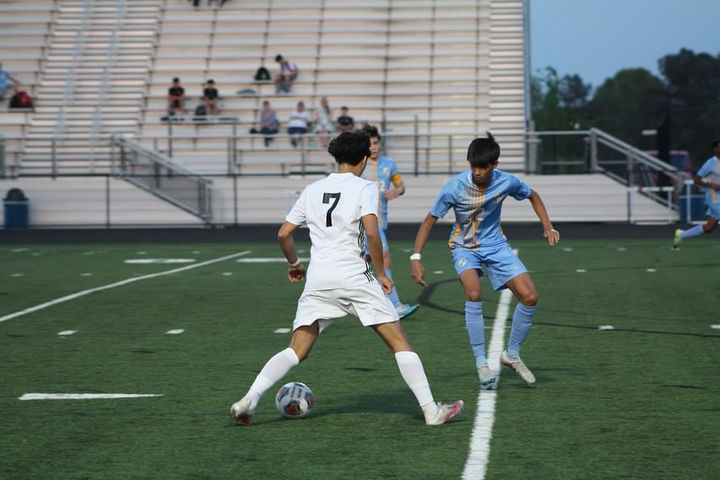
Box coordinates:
[0,238,720,480]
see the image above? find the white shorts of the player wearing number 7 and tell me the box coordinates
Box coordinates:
[293,280,400,331]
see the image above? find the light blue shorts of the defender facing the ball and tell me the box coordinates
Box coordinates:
[452,242,527,290]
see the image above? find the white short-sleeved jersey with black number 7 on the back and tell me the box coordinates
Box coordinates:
[285,173,378,291]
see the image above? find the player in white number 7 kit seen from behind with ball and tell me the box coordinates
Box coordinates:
[230,132,463,425]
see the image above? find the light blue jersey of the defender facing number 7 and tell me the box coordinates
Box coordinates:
[430,169,532,249]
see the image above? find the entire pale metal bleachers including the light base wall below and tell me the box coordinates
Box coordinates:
[0,0,676,226]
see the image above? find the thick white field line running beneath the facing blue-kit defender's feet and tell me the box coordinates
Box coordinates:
[462,250,518,480]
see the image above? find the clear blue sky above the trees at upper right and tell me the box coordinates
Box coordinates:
[529,0,720,87]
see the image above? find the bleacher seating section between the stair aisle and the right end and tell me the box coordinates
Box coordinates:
[141,0,525,173]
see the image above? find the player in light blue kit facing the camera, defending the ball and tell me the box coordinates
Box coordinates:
[410,133,560,390]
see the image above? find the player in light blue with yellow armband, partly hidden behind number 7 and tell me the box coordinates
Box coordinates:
[362,125,419,318]
